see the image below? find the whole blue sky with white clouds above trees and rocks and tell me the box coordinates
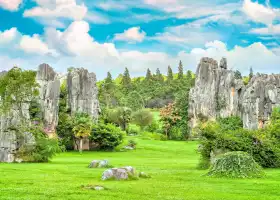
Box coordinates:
[0,0,280,79]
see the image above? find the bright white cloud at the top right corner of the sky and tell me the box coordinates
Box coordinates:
[242,0,278,25]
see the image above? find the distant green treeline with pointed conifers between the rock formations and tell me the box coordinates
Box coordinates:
[98,61,194,110]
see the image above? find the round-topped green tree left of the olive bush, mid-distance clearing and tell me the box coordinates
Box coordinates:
[108,107,132,131]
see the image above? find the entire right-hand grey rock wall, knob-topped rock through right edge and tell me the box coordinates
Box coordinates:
[189,58,280,129]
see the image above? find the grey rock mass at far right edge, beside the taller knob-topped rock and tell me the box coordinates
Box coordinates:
[240,74,280,129]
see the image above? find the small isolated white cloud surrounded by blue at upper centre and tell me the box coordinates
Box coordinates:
[114,27,146,42]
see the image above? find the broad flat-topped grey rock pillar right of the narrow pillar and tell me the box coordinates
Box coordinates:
[67,68,100,119]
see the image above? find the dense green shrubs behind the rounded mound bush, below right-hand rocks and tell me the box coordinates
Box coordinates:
[197,114,280,168]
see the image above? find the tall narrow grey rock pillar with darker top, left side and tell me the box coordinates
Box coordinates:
[36,64,60,133]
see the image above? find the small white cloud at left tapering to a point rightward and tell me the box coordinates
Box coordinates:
[19,34,58,56]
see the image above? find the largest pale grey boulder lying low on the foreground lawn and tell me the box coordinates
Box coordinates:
[101,166,135,181]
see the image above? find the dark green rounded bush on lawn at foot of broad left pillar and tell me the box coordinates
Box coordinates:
[89,123,125,151]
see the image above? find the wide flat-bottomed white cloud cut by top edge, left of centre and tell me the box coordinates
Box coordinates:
[23,0,87,20]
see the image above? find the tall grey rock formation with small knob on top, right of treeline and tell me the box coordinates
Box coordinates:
[189,58,244,127]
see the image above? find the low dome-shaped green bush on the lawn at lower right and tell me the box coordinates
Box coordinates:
[207,151,264,178]
